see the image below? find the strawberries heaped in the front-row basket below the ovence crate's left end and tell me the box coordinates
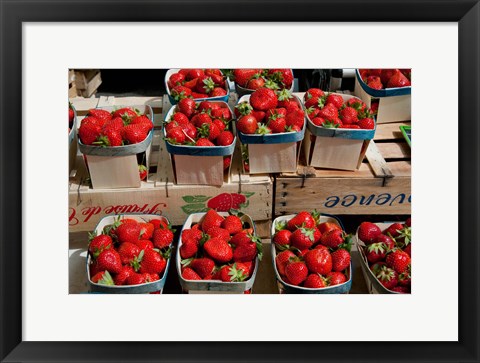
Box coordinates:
[272,211,352,289]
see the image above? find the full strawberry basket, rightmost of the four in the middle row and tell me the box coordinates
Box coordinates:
[303,88,376,170]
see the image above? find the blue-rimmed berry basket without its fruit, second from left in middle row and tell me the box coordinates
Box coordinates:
[163,101,237,186]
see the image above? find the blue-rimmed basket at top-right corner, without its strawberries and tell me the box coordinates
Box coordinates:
[354,69,412,124]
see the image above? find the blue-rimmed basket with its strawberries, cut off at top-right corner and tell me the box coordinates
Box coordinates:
[355,69,412,123]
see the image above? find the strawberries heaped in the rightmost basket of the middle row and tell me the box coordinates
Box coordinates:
[303,88,375,130]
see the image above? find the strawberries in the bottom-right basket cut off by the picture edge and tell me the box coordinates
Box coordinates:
[357,218,412,294]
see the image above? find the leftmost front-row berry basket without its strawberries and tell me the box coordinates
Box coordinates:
[86,213,173,294]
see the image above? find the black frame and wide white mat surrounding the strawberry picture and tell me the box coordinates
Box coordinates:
[0,0,480,362]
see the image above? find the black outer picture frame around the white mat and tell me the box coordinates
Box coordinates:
[0,0,480,362]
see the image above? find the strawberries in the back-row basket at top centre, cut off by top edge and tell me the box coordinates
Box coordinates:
[233,68,293,90]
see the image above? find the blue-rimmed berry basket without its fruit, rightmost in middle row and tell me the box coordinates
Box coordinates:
[303,92,376,170]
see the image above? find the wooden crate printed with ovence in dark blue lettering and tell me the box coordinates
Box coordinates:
[274,122,411,216]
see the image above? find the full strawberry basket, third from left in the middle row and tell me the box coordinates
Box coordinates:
[235,88,305,174]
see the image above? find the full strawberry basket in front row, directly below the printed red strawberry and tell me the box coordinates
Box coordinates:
[176,209,262,294]
